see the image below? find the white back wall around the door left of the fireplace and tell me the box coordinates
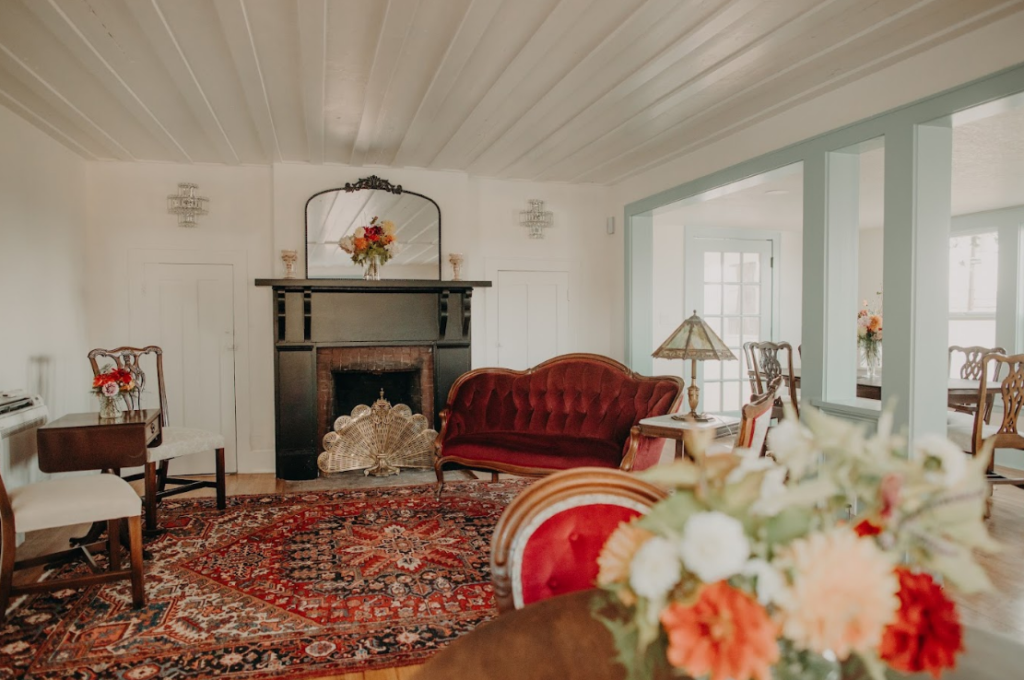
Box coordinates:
[81,163,273,472]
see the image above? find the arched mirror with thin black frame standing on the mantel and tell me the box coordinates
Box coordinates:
[306,175,441,281]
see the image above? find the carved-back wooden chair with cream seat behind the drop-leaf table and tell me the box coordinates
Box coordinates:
[89,345,226,532]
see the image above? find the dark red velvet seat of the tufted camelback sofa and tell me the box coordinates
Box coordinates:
[441,432,623,470]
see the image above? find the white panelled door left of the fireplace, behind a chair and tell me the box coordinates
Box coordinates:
[135,262,237,474]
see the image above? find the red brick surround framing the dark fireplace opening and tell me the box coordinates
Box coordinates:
[316,345,434,441]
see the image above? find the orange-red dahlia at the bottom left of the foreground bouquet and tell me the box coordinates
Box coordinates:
[662,581,778,680]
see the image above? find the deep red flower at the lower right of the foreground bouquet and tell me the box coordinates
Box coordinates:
[879,566,964,678]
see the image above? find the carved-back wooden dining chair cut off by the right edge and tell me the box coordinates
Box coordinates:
[946,352,1024,517]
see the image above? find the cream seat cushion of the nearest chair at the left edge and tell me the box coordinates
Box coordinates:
[10,474,142,532]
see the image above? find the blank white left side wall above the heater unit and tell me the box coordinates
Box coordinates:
[0,107,91,418]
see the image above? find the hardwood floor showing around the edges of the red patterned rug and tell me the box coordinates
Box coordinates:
[8,473,1024,680]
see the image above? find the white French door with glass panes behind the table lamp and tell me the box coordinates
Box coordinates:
[685,238,773,414]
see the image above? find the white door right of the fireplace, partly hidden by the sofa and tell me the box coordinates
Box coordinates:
[497,270,569,370]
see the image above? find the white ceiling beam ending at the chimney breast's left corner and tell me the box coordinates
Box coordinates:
[214,0,283,162]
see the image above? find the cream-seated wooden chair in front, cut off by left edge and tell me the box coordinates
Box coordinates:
[0,466,145,623]
